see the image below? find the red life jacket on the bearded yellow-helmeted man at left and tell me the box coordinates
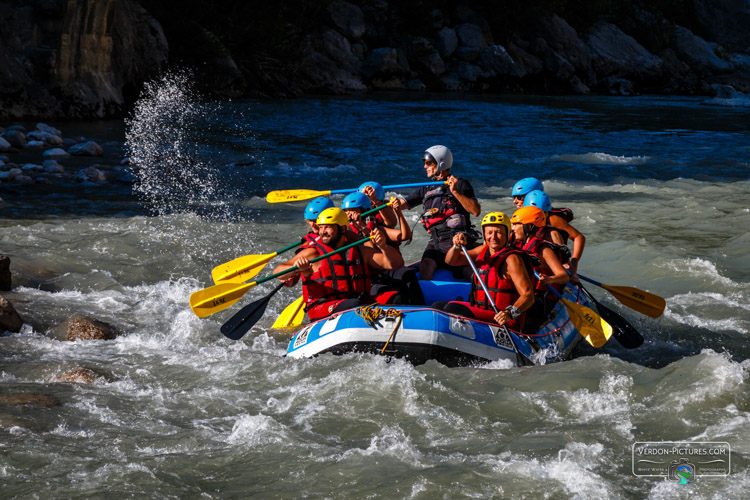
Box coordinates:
[302,237,372,311]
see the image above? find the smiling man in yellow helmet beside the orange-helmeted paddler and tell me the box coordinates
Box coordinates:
[433,212,534,331]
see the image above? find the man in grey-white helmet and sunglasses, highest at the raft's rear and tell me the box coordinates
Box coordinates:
[405,146,482,280]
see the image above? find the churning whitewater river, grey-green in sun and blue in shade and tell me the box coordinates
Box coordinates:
[0,79,750,499]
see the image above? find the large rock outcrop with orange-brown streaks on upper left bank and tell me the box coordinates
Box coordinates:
[0,0,168,118]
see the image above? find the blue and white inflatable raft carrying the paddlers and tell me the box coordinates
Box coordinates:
[287,274,595,366]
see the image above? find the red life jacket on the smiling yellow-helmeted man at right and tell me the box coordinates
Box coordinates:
[469,247,534,312]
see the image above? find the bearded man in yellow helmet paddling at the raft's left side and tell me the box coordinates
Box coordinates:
[274,207,404,320]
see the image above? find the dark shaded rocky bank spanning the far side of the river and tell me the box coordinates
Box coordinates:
[0,0,750,118]
